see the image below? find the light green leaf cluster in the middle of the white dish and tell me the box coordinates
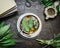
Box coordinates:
[22,17,34,32]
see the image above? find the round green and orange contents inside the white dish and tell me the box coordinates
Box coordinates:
[20,15,39,34]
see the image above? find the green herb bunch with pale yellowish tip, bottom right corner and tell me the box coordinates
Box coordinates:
[37,33,60,48]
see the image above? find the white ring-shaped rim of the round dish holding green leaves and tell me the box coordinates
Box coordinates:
[17,13,42,38]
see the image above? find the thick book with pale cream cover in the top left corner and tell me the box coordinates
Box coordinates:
[0,0,17,18]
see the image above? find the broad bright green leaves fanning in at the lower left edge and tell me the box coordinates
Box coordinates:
[0,23,16,48]
